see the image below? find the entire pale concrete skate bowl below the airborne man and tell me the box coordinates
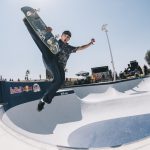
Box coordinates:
[0,79,150,150]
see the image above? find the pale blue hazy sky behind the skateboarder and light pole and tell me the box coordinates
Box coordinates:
[0,0,150,79]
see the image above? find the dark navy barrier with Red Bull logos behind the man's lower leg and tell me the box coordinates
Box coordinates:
[0,81,51,109]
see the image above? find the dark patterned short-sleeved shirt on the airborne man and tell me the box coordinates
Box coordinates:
[57,40,78,68]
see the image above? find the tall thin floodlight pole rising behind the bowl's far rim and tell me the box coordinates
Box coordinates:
[102,24,116,81]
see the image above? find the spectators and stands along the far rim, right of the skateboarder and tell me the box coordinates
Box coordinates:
[65,61,150,86]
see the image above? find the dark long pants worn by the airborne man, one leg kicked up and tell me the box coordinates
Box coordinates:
[23,19,65,103]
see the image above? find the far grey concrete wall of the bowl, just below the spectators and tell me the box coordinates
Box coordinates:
[71,76,150,98]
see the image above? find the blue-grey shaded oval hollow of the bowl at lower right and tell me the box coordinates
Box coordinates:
[68,114,150,148]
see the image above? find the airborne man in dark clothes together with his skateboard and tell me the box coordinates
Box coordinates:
[21,6,95,111]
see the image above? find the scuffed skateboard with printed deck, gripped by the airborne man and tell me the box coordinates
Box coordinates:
[21,6,60,54]
